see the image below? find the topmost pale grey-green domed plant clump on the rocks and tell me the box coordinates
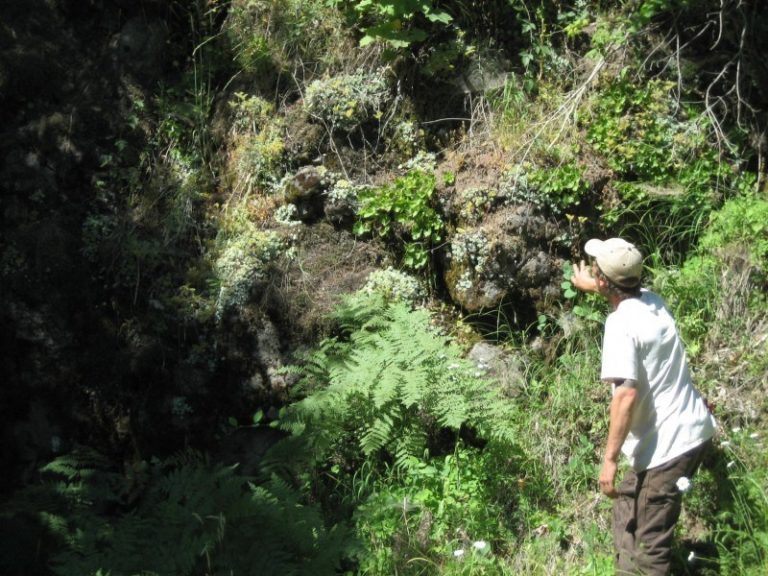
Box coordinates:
[304,68,390,132]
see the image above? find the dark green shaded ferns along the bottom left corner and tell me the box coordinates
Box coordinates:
[3,449,348,576]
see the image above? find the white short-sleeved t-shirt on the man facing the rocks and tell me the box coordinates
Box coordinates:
[600,290,715,472]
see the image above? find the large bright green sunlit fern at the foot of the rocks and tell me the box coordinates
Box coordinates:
[281,294,516,474]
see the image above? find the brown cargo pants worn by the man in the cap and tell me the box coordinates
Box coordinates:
[613,440,712,576]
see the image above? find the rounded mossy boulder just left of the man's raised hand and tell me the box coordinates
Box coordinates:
[445,204,563,312]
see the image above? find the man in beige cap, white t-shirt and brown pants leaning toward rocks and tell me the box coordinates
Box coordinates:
[571,238,715,575]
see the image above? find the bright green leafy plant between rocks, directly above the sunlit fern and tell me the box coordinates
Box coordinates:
[354,170,443,269]
